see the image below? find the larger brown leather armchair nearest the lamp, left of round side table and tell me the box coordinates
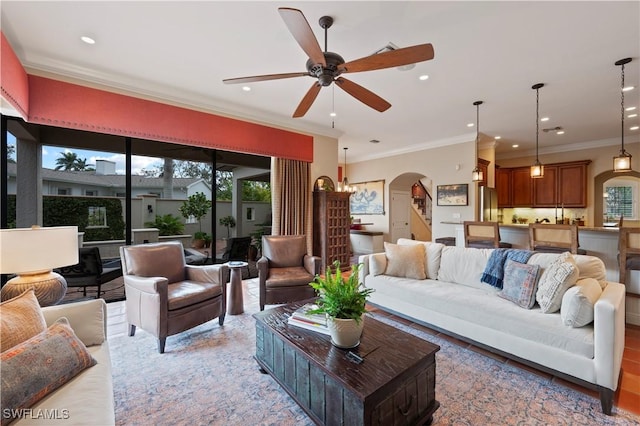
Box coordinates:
[120,241,229,353]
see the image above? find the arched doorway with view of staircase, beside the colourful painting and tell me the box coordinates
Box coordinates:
[389,173,432,242]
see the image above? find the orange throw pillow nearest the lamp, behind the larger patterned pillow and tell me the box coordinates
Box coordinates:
[0,289,47,352]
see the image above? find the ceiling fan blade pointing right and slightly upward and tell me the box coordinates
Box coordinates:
[340,43,434,72]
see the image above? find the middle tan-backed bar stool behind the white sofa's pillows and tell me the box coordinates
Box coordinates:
[529,223,587,254]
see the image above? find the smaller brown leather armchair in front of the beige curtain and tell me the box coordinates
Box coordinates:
[257,235,321,311]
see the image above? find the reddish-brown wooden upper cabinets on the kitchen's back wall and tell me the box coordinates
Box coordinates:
[496,160,591,208]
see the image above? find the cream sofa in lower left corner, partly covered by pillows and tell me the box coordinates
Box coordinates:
[12,299,115,426]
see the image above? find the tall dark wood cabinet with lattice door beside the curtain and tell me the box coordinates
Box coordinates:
[313,191,351,273]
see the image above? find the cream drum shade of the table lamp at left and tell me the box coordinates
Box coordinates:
[0,226,78,274]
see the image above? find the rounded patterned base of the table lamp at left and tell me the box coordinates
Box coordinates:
[0,271,67,306]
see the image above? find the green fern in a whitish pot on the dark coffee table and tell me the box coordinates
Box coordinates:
[309,261,374,348]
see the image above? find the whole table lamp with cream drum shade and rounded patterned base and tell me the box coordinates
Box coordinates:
[0,226,78,306]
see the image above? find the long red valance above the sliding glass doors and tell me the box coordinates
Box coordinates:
[29,75,313,162]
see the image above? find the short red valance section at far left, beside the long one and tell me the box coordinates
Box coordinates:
[0,32,29,120]
